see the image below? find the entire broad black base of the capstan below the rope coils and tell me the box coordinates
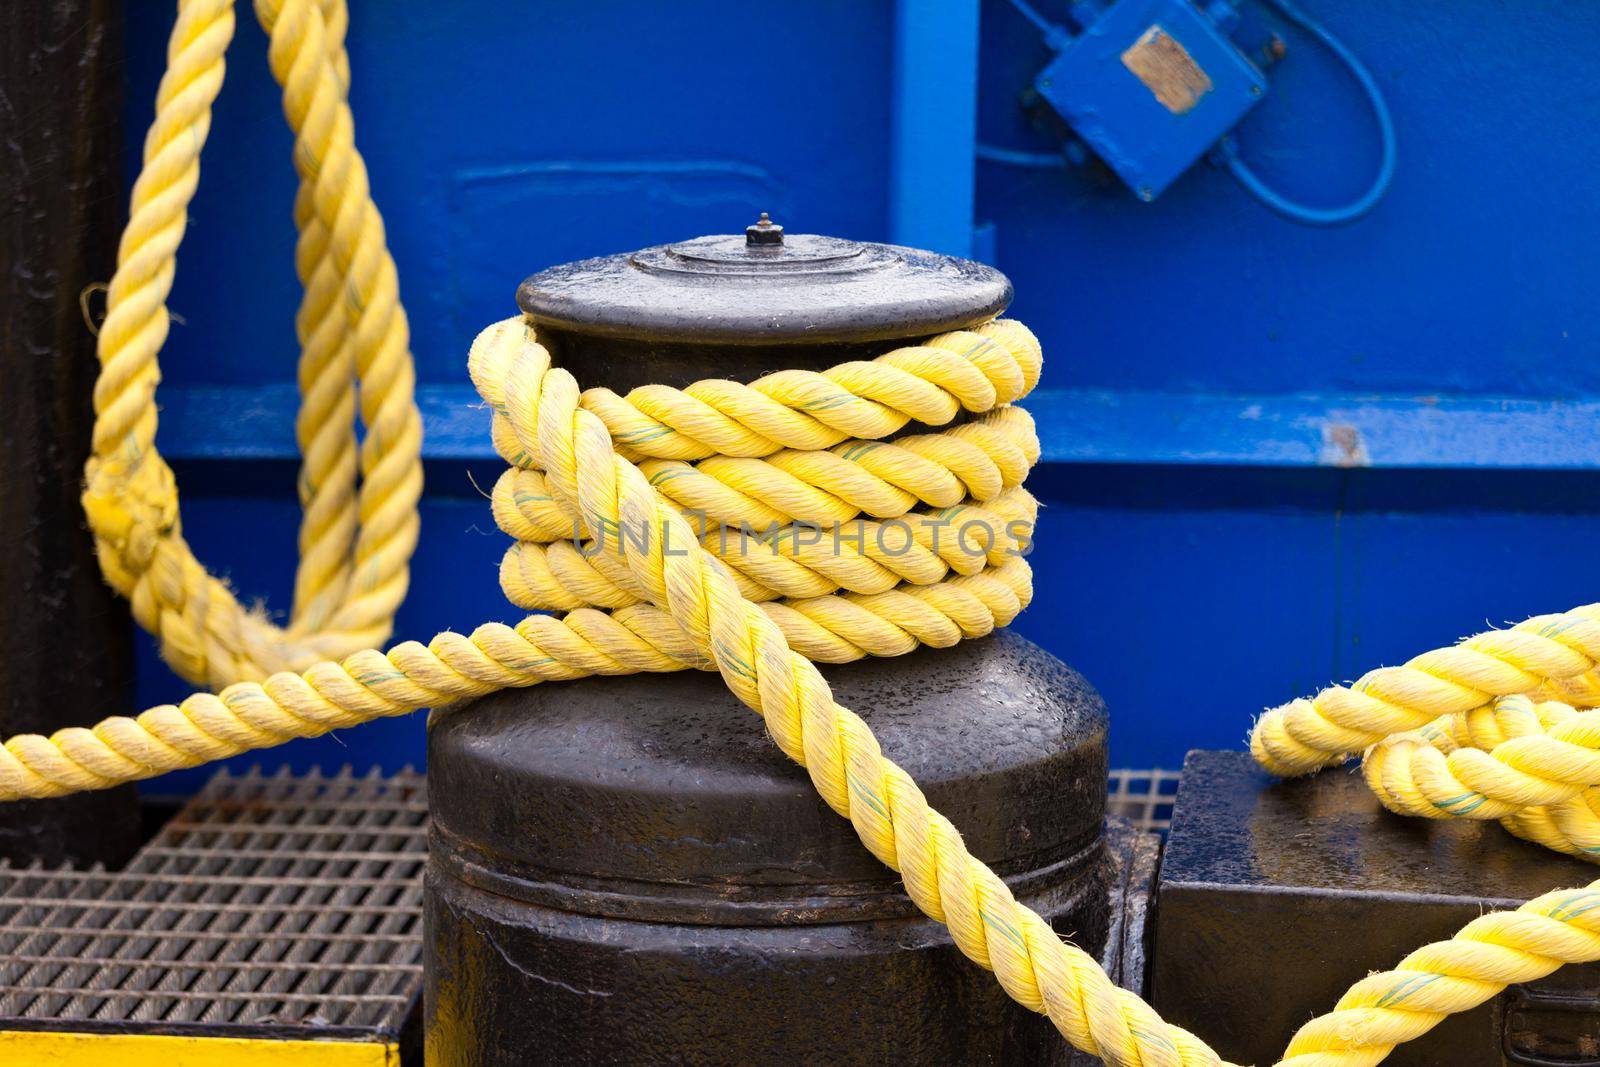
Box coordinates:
[427,633,1113,1065]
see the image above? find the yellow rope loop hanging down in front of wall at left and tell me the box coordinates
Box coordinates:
[83,0,422,686]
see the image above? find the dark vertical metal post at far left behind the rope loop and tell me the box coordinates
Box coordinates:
[0,0,139,864]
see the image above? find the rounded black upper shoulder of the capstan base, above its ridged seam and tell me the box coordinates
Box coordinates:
[429,633,1106,925]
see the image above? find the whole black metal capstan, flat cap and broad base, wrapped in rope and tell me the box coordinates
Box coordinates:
[422,216,1155,1067]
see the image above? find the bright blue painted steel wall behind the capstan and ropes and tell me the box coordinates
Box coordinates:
[121,0,1600,787]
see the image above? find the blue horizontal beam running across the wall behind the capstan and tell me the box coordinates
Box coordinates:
[158,386,1600,470]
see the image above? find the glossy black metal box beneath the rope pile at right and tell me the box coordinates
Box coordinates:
[1150,752,1600,1067]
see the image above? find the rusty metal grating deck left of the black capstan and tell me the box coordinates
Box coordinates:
[0,771,427,1043]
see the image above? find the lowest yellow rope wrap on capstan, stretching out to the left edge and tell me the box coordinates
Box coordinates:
[0,560,1032,801]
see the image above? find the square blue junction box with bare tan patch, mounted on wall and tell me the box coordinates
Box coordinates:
[1034,0,1267,200]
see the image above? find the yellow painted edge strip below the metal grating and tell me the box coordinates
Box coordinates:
[0,1030,400,1067]
